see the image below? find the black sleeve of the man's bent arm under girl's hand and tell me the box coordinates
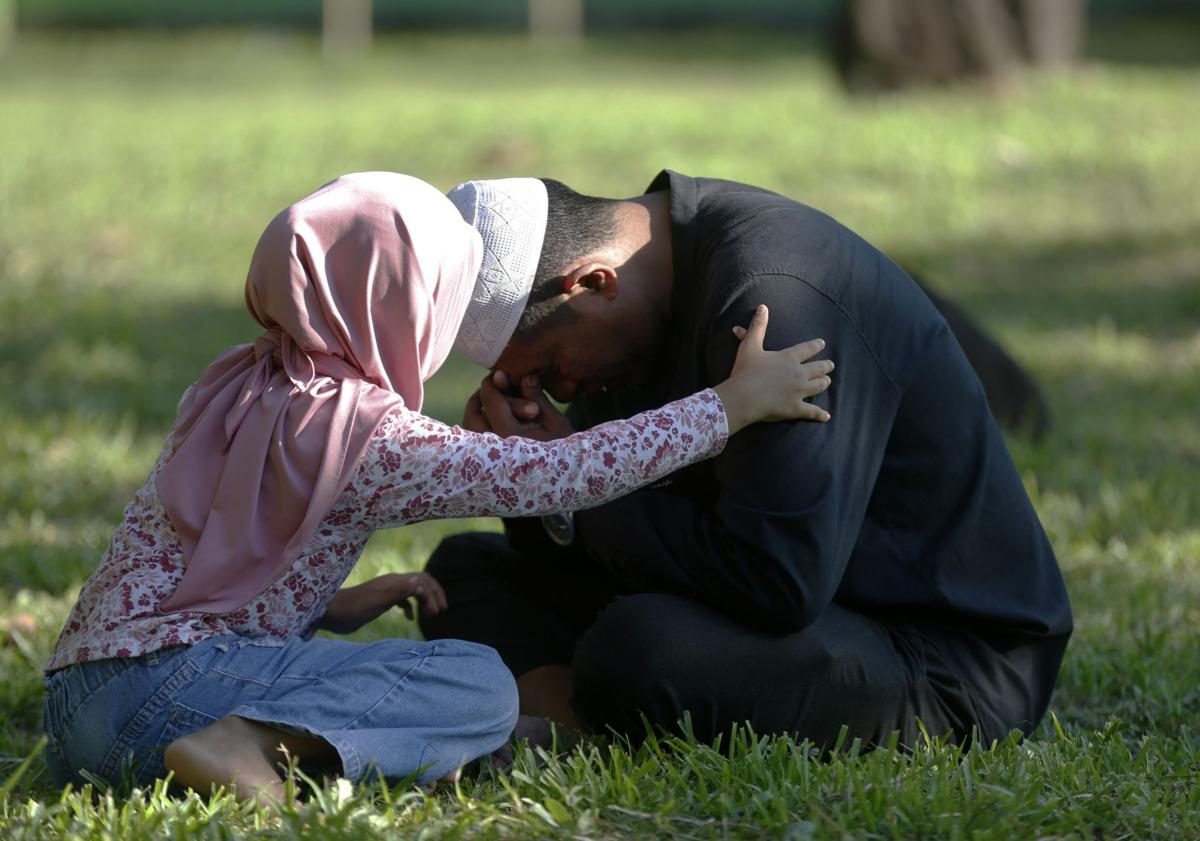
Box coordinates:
[576,275,899,631]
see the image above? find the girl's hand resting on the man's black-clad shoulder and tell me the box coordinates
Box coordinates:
[715,305,834,434]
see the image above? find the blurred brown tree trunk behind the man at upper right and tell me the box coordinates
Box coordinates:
[833,0,1087,90]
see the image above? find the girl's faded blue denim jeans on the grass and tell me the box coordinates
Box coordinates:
[44,636,517,786]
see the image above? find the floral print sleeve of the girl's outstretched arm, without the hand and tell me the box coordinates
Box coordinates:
[354,389,728,529]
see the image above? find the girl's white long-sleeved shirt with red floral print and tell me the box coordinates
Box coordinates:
[46,389,728,671]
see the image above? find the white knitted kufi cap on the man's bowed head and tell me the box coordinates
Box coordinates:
[446,178,547,368]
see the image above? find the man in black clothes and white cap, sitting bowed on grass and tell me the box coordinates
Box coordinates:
[421,172,1072,745]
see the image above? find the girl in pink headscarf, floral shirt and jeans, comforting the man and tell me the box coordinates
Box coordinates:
[46,173,832,798]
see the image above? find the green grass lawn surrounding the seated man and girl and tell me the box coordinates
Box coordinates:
[0,27,1200,839]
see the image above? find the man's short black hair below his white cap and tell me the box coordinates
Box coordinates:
[514,178,620,341]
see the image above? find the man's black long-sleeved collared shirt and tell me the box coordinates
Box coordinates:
[561,170,1072,647]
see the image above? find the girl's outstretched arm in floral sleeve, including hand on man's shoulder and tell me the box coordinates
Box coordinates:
[354,310,833,529]
